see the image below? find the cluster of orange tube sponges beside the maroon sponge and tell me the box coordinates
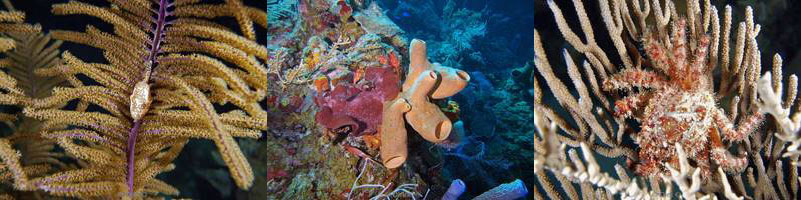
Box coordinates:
[381,39,470,168]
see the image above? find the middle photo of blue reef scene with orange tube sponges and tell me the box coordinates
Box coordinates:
[256,0,534,199]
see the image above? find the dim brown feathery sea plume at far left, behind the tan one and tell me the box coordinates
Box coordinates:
[2,16,69,199]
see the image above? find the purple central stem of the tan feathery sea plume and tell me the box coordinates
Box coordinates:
[126,0,173,196]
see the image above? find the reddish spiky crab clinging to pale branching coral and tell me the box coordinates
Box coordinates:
[603,20,762,180]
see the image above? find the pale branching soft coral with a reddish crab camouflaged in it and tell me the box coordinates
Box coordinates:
[534,0,801,199]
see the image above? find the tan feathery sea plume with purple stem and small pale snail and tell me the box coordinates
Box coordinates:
[25,0,267,198]
